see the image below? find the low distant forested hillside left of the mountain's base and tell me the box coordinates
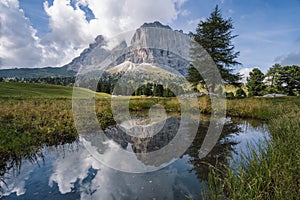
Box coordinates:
[0,67,76,78]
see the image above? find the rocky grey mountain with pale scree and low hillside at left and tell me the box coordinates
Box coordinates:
[0,21,190,78]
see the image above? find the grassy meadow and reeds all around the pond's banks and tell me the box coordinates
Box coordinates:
[0,82,300,199]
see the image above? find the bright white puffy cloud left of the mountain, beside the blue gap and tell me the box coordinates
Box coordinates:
[41,0,97,66]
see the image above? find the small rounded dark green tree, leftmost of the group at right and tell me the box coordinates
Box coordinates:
[246,68,265,96]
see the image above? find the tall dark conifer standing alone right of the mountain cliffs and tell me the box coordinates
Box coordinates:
[188,5,241,89]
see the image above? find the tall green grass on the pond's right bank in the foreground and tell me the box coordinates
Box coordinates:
[206,99,300,199]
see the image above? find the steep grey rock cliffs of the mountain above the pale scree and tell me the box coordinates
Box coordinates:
[64,22,190,74]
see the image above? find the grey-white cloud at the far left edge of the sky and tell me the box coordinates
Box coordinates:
[0,0,42,67]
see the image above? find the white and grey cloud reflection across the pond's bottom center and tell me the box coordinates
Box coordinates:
[49,141,178,199]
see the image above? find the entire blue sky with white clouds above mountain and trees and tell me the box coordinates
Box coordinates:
[0,0,300,76]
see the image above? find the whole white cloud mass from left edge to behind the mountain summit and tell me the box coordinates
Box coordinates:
[0,0,186,68]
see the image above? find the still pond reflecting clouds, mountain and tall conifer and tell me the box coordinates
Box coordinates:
[0,116,269,200]
